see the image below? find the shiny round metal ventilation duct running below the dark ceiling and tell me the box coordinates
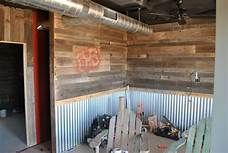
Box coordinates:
[4,0,153,34]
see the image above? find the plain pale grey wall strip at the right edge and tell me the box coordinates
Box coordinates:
[212,0,228,153]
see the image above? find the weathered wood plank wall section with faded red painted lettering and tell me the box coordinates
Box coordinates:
[54,14,127,101]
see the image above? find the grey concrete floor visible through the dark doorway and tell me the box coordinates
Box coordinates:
[0,113,26,153]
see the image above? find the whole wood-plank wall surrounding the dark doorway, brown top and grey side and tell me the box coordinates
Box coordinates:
[0,5,36,146]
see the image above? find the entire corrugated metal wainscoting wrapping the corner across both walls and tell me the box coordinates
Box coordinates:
[56,88,213,153]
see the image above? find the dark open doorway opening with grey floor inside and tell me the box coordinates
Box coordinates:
[0,43,27,153]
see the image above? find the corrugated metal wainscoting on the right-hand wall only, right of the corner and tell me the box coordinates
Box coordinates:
[130,89,213,131]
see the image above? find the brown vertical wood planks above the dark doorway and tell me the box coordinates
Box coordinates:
[0,5,33,66]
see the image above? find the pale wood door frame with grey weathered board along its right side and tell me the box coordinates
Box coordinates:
[0,41,37,147]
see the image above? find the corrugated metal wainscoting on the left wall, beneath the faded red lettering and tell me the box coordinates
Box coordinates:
[55,91,126,153]
